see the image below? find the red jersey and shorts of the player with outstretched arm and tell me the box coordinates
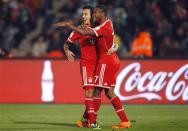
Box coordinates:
[88,19,120,88]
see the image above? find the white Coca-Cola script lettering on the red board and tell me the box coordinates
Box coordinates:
[115,63,188,101]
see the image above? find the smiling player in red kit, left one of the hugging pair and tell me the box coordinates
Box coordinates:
[64,6,97,127]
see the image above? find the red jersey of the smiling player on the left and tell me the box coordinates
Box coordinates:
[68,31,97,64]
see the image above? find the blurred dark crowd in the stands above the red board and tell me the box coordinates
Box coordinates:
[0,0,188,58]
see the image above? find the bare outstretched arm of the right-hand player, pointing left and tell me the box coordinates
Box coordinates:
[54,22,95,36]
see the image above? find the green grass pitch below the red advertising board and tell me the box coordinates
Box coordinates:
[0,104,188,131]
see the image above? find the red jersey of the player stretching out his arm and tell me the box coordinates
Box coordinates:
[88,19,117,62]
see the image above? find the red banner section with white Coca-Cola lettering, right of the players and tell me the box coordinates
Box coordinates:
[115,60,188,104]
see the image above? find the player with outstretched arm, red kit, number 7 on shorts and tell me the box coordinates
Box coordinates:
[54,5,131,128]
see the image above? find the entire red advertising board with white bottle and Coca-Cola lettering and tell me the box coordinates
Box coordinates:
[0,59,188,104]
